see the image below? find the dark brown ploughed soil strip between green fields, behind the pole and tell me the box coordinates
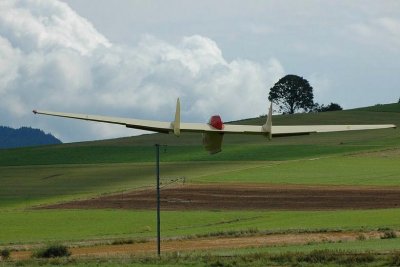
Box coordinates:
[42,185,400,210]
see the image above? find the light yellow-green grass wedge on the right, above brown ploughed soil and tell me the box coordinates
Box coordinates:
[193,153,400,186]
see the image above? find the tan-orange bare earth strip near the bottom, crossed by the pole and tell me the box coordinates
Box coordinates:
[12,231,390,260]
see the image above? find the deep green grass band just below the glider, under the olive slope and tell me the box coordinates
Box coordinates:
[0,139,400,167]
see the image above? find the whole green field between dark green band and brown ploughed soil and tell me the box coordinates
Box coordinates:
[0,153,400,208]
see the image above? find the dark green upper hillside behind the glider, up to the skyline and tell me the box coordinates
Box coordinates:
[0,104,400,166]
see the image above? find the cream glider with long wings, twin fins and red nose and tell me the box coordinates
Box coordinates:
[33,98,396,154]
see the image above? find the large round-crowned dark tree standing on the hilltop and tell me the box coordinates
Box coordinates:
[268,75,314,114]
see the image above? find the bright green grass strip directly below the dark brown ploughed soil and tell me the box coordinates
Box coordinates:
[0,209,400,245]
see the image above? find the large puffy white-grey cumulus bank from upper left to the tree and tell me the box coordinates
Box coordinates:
[0,0,284,141]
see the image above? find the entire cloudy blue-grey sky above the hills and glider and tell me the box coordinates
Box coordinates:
[0,0,400,142]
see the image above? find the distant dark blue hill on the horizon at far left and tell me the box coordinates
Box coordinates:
[0,126,62,148]
